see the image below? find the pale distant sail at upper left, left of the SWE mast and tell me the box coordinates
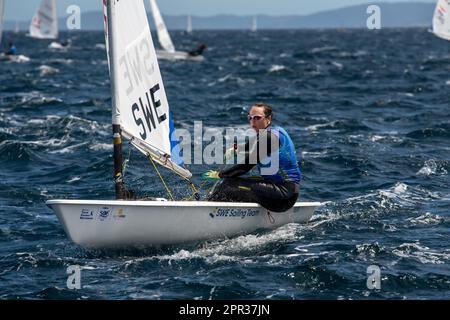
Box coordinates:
[30,0,58,39]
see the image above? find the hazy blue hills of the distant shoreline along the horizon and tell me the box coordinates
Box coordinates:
[4,2,436,32]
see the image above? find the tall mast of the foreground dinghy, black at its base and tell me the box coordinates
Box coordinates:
[106,0,126,199]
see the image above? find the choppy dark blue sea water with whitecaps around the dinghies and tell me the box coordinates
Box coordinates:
[0,29,450,299]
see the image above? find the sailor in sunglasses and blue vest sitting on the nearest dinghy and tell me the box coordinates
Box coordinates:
[202,103,301,212]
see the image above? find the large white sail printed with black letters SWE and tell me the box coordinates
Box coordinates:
[103,0,192,178]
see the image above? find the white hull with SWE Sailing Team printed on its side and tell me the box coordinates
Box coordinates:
[46,200,320,248]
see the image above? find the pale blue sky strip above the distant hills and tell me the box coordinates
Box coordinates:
[5,0,437,21]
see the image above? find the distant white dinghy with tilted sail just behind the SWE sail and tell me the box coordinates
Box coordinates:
[149,0,205,61]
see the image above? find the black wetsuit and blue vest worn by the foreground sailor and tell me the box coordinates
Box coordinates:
[208,128,300,212]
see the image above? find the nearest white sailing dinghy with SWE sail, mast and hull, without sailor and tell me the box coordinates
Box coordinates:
[46,0,320,248]
